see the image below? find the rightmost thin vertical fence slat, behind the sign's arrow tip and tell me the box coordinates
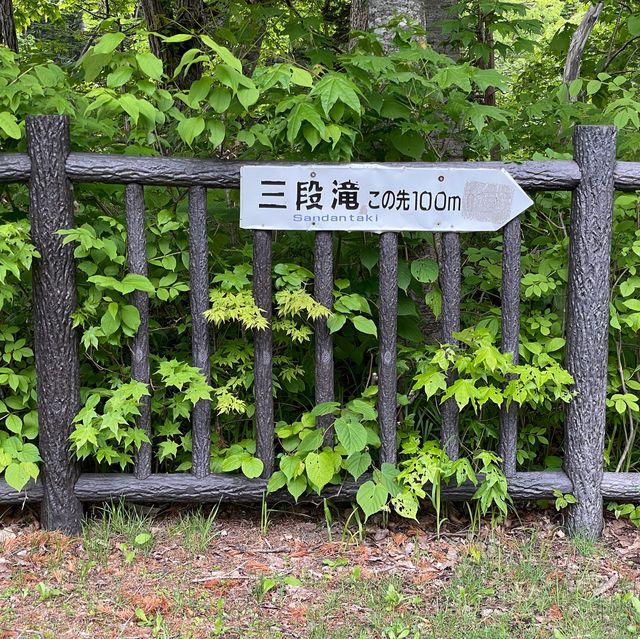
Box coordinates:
[498,216,521,477]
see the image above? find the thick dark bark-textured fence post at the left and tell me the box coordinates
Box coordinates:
[26,116,82,535]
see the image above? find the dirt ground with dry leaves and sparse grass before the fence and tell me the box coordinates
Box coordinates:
[0,505,640,639]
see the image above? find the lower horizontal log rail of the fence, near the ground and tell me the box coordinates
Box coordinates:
[6,471,640,504]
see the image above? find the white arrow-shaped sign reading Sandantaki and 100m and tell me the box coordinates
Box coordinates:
[240,164,532,232]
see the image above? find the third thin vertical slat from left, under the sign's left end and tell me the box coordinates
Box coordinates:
[253,231,275,477]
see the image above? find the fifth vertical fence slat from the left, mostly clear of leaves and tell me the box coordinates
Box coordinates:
[378,233,398,464]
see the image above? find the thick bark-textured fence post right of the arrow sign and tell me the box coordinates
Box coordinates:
[564,126,616,539]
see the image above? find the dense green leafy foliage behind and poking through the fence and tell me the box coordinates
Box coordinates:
[0,3,640,516]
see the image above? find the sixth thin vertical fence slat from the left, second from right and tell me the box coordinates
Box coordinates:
[440,233,460,459]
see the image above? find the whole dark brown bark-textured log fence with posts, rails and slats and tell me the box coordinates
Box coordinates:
[0,116,640,537]
